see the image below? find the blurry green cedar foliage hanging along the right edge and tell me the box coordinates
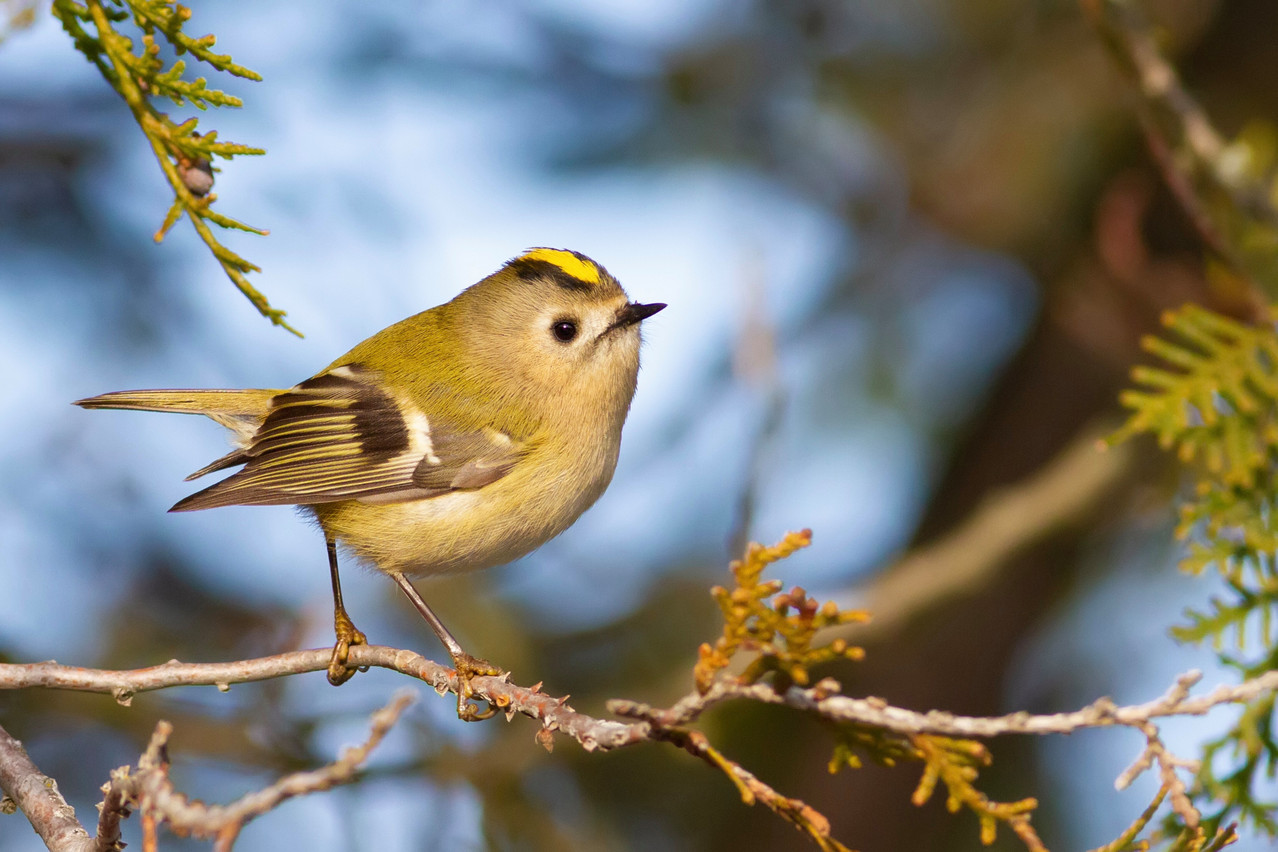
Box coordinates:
[1112,305,1278,837]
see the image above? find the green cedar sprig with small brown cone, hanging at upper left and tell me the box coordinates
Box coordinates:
[52,0,298,335]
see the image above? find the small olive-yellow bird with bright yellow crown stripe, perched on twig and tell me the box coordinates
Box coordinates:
[75,248,666,720]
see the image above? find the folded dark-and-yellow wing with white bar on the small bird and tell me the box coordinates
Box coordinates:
[171,364,525,512]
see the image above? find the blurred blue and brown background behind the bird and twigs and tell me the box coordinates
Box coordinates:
[0,0,1278,852]
